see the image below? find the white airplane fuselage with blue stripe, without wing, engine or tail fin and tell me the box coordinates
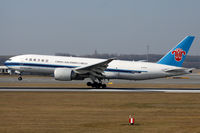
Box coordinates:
[5,55,190,80]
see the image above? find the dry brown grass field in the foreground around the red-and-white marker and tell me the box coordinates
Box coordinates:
[0,92,200,133]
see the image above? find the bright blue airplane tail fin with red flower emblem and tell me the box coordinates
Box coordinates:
[157,36,194,67]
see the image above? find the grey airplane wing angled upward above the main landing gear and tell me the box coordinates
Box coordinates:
[75,58,114,78]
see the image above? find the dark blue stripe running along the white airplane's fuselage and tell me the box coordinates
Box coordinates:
[4,62,147,73]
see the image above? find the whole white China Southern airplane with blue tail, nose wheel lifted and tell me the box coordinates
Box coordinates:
[4,36,195,88]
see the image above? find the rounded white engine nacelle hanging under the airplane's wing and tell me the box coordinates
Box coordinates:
[54,68,76,81]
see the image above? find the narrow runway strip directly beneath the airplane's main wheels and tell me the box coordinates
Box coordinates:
[0,87,200,93]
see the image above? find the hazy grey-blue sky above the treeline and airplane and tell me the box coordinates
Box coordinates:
[0,0,200,55]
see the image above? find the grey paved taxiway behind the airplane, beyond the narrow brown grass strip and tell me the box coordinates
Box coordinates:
[0,73,200,84]
